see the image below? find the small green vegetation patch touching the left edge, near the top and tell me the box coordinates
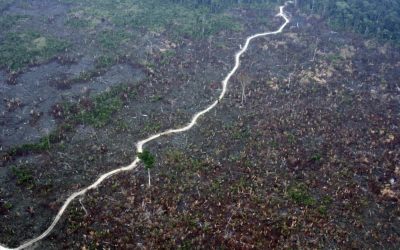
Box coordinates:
[0,32,68,72]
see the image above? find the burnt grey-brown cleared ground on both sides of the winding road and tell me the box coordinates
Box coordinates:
[0,1,400,249]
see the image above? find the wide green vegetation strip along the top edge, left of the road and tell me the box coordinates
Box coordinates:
[67,0,241,39]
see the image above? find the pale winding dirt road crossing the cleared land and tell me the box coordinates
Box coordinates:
[0,1,292,250]
